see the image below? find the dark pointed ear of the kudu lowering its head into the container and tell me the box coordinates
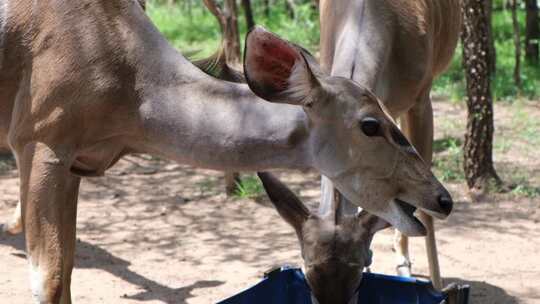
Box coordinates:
[257,172,310,234]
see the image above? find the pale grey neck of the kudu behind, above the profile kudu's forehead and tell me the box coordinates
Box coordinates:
[321,0,393,99]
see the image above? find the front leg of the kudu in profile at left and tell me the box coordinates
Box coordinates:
[17,142,80,304]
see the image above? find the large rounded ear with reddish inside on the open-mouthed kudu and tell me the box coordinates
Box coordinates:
[244,26,321,106]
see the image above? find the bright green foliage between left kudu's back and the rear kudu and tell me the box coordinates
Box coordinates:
[147,1,319,57]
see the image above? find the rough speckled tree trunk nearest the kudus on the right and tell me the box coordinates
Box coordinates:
[462,0,501,191]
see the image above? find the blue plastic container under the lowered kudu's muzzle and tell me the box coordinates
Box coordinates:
[218,268,452,304]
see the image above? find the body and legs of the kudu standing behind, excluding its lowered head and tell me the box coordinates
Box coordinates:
[320,0,461,289]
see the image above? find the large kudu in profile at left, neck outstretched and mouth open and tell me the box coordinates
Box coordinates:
[0,0,452,303]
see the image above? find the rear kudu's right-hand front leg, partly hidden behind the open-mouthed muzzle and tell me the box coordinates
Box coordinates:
[400,88,442,290]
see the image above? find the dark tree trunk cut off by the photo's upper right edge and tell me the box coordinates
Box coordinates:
[525,0,540,64]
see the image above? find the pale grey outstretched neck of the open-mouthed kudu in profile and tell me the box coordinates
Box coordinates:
[136,30,311,171]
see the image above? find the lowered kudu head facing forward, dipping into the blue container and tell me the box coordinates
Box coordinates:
[258,173,389,304]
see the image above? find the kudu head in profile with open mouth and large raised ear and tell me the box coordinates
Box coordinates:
[244,27,453,236]
